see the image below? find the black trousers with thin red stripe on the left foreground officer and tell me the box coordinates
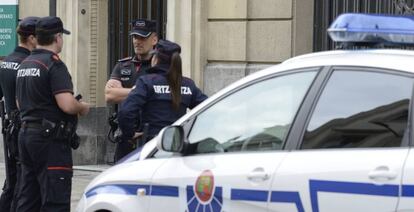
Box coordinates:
[17,127,73,212]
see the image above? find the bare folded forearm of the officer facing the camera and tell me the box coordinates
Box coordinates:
[105,79,131,104]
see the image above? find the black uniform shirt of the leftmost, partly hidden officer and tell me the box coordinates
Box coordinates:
[0,46,30,113]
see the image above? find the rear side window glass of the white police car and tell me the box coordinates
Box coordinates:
[302,70,413,149]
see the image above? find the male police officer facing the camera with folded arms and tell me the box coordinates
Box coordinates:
[105,19,158,161]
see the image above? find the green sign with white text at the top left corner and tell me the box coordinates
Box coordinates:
[0,0,18,57]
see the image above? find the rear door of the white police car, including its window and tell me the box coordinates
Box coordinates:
[269,68,413,212]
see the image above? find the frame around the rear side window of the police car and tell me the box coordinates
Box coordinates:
[292,65,414,151]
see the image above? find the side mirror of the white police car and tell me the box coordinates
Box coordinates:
[157,126,184,152]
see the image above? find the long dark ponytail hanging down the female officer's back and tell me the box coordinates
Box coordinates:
[167,52,183,111]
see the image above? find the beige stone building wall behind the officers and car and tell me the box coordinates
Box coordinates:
[14,0,313,164]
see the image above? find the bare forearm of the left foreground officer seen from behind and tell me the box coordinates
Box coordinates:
[55,92,89,115]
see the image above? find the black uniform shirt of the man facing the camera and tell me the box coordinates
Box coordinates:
[111,57,151,88]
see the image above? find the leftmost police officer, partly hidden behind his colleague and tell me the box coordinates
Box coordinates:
[0,17,39,211]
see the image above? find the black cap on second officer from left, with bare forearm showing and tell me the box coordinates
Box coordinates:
[36,16,70,35]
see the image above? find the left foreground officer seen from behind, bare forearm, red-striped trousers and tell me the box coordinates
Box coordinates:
[16,16,89,212]
